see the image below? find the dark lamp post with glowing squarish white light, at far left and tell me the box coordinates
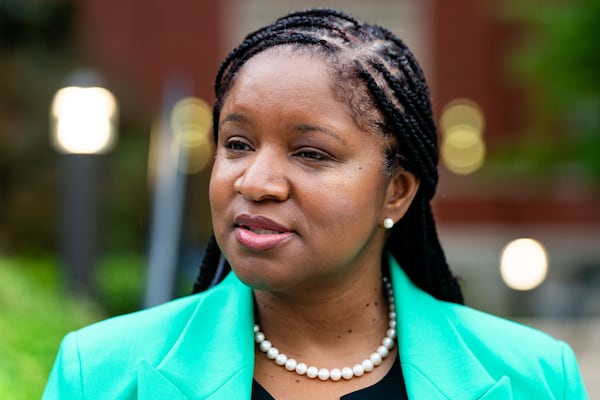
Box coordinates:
[50,72,118,294]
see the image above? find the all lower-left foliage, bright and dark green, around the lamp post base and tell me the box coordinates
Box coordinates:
[0,254,151,400]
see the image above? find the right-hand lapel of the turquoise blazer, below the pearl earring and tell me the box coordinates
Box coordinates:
[390,257,512,400]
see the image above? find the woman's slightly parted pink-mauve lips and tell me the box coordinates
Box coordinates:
[234,214,294,251]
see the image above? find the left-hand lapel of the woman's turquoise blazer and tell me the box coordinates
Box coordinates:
[138,273,254,400]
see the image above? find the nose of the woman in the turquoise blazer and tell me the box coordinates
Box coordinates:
[234,150,290,201]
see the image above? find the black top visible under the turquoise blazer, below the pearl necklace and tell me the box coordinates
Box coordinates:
[252,357,408,400]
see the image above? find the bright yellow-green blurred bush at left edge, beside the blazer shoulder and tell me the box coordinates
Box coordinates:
[0,258,104,400]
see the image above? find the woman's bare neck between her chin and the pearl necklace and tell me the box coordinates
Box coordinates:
[254,276,389,366]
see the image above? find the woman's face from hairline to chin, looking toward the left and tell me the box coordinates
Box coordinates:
[210,48,410,292]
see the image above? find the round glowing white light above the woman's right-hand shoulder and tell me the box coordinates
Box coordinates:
[500,238,548,290]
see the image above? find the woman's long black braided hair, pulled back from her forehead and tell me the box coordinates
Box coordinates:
[194,8,463,303]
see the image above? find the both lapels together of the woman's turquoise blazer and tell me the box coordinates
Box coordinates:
[138,257,512,400]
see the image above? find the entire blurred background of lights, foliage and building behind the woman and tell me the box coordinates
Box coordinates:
[0,0,600,399]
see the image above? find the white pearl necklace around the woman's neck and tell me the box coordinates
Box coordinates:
[254,277,396,381]
